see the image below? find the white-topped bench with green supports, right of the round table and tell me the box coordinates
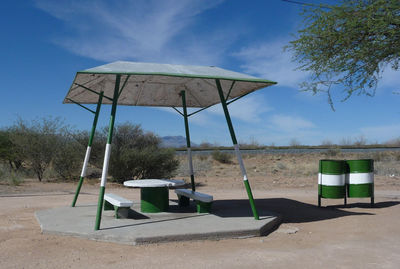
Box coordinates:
[175,189,213,213]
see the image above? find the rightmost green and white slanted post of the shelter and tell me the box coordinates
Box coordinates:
[215,79,260,220]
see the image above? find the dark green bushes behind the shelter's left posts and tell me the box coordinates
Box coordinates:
[0,118,179,182]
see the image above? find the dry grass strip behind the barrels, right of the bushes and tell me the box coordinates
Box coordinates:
[177,150,400,189]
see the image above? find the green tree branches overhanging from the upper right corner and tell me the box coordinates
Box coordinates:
[288,0,400,108]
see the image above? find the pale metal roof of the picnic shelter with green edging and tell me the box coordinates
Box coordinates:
[63,61,276,108]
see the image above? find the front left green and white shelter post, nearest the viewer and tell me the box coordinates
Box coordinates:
[94,75,121,231]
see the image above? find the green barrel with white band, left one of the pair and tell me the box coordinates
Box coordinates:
[318,160,346,199]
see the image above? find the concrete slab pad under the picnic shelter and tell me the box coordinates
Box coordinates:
[35,200,281,245]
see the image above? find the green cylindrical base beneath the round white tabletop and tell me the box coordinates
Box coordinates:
[140,187,169,213]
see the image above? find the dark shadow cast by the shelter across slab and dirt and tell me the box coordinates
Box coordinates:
[200,198,378,223]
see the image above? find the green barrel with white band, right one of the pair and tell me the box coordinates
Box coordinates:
[346,159,374,198]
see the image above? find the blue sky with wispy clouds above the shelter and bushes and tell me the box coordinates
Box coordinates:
[0,0,400,145]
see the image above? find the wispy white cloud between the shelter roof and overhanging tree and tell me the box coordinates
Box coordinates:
[234,39,308,88]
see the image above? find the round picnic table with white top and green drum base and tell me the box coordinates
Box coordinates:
[124,179,185,213]
